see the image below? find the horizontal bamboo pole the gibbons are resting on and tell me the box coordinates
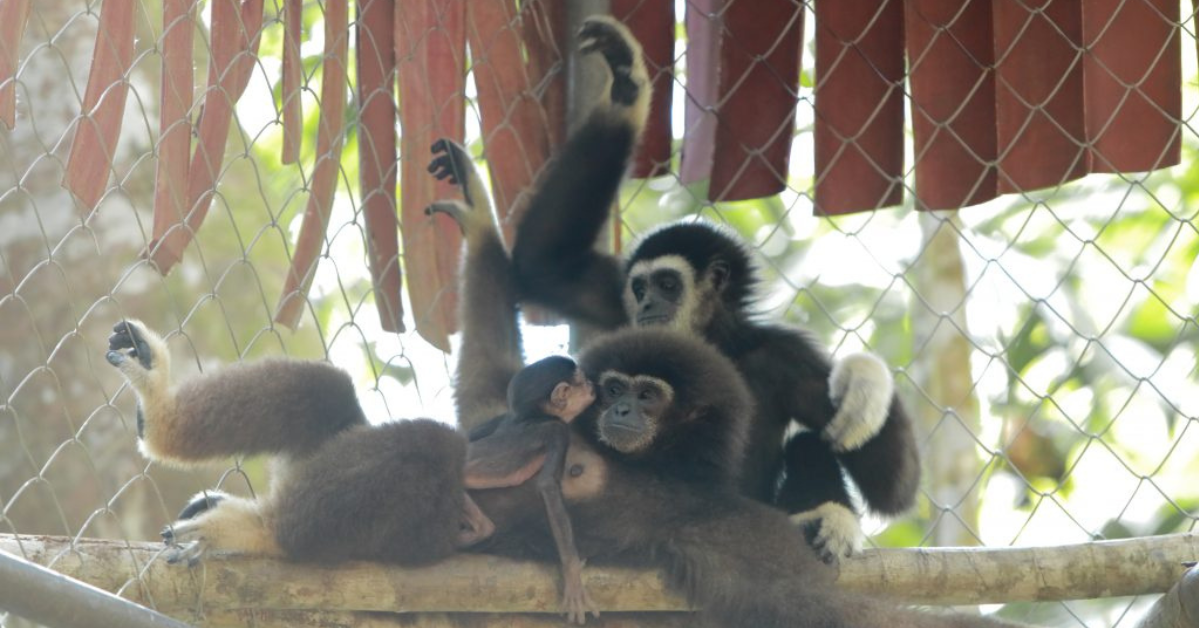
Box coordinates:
[0,533,1199,614]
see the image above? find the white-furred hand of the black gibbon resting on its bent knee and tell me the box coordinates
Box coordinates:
[823,354,894,453]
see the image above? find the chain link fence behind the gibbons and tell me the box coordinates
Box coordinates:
[0,0,1199,627]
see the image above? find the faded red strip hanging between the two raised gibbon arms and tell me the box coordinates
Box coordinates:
[466,0,553,242]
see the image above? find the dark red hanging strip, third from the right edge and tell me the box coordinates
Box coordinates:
[905,0,998,210]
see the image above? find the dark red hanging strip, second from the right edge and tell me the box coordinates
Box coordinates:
[993,0,1087,194]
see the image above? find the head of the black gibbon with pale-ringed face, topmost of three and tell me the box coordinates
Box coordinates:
[623,222,755,333]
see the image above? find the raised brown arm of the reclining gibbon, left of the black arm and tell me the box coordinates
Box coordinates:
[427,139,522,431]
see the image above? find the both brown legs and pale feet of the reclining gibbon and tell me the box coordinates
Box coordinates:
[107,321,477,564]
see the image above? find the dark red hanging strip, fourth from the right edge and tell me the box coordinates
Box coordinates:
[815,0,904,215]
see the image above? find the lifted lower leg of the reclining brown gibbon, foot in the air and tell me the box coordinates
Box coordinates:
[106,320,366,465]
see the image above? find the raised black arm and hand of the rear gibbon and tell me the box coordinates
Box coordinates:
[512,18,652,328]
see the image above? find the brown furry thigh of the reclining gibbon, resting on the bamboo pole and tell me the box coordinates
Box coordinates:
[275,419,466,564]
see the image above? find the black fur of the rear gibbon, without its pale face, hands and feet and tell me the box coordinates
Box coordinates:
[512,51,920,514]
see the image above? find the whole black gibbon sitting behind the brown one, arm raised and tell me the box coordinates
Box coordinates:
[508,11,920,560]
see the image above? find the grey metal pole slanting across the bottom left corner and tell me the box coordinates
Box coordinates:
[0,551,188,628]
